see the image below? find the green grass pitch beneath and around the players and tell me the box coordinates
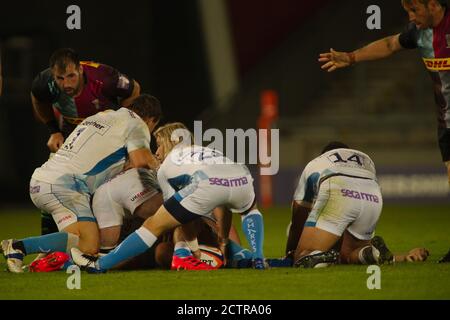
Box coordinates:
[0,205,450,300]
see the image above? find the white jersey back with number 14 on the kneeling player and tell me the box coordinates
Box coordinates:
[305,148,376,180]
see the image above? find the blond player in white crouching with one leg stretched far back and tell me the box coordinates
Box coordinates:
[71,123,264,272]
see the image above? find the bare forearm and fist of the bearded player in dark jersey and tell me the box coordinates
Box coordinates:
[31,93,64,152]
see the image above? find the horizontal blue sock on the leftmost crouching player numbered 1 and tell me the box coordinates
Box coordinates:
[20,232,68,254]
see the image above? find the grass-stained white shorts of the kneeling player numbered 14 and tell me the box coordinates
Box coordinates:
[305,176,383,240]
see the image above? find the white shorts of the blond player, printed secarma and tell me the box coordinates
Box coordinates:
[164,170,255,223]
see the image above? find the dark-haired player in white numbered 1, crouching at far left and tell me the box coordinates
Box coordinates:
[2,94,161,272]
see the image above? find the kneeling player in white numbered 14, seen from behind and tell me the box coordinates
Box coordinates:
[287,142,392,267]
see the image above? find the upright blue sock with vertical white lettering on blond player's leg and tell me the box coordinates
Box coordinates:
[242,210,264,259]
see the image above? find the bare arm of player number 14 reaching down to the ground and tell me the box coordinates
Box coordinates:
[286,200,312,256]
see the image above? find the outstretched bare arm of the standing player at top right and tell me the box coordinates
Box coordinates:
[319,34,402,72]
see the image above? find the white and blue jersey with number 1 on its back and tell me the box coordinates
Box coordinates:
[32,108,150,193]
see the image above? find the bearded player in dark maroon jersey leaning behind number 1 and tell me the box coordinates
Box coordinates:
[31,48,140,238]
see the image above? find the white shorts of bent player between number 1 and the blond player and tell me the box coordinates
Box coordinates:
[92,169,159,229]
